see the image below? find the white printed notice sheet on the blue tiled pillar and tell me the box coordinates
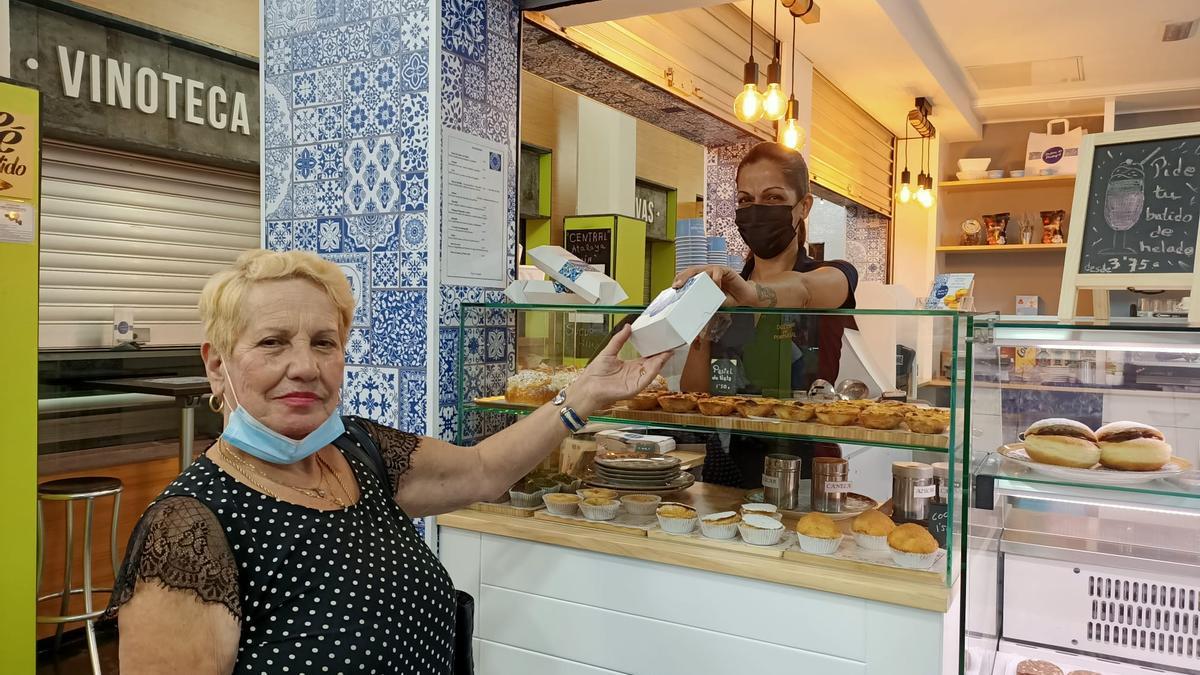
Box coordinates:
[442,130,510,288]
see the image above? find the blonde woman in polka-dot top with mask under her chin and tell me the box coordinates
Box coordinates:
[114,251,667,675]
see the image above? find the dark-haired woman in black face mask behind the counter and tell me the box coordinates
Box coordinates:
[674,143,858,488]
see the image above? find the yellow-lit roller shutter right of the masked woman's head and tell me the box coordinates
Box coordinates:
[809,71,895,216]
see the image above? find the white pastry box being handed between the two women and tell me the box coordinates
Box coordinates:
[630,274,725,356]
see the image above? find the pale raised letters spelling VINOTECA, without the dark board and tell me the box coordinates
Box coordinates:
[56,44,250,136]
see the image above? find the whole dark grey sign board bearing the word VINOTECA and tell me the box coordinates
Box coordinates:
[8,0,260,171]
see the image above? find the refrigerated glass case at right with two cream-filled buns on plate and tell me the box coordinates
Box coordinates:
[965,317,1200,675]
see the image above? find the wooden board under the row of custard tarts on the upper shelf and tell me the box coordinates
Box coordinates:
[614,406,950,448]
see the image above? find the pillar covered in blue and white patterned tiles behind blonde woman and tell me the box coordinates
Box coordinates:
[263,0,520,438]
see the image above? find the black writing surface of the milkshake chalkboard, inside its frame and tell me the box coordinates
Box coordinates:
[1079,137,1200,274]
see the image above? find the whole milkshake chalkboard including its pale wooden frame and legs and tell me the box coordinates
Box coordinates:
[1058,124,1200,324]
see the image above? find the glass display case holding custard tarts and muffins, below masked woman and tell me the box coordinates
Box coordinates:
[456,303,973,586]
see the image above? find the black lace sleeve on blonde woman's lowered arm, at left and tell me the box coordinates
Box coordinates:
[108,496,241,621]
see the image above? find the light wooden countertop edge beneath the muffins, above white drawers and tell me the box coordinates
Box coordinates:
[437,510,955,613]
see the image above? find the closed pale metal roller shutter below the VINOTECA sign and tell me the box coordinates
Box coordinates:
[38,142,260,348]
